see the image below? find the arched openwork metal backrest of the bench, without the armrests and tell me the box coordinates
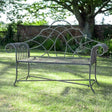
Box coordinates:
[26,20,102,57]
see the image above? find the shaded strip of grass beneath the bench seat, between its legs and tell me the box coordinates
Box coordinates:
[28,64,89,78]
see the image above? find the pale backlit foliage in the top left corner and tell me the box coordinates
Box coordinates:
[0,0,27,23]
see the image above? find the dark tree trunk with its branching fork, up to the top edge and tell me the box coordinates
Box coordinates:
[72,0,95,38]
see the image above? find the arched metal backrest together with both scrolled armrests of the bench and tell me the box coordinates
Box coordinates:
[6,20,108,63]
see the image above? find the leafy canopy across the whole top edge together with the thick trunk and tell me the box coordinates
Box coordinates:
[0,0,112,37]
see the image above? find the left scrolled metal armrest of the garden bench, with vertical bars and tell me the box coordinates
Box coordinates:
[5,42,30,61]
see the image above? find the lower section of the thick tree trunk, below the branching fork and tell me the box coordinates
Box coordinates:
[78,18,95,38]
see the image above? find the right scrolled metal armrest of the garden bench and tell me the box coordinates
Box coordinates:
[90,43,108,64]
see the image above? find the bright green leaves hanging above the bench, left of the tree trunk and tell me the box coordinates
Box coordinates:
[26,0,71,20]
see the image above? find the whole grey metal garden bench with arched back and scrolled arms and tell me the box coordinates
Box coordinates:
[5,20,108,92]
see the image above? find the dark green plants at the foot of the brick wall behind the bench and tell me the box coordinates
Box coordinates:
[28,34,109,56]
